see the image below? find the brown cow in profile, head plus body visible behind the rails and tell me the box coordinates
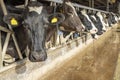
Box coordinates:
[44,0,85,43]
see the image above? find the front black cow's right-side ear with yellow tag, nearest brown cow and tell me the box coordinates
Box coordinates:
[44,13,65,25]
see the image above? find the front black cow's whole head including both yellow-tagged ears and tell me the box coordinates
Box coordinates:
[4,1,64,62]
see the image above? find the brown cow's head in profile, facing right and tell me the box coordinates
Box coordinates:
[62,0,85,31]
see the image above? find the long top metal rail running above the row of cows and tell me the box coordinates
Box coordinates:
[43,0,109,13]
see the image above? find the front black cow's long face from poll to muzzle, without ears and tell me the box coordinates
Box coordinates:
[24,1,47,62]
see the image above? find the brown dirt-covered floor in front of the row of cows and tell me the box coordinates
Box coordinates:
[39,25,120,80]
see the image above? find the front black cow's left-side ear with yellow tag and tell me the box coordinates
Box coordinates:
[3,14,22,27]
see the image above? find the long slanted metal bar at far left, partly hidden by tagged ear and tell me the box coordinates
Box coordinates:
[0,0,23,59]
